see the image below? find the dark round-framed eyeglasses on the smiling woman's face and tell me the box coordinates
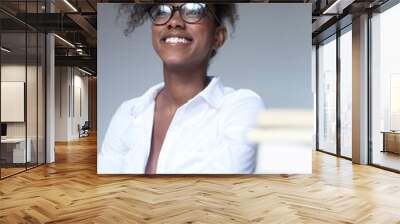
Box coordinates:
[149,3,221,25]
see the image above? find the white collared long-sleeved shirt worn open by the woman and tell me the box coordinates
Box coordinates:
[97,77,264,174]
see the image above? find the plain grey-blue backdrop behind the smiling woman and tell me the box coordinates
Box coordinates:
[97,3,313,146]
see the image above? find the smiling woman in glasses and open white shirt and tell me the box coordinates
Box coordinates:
[98,3,264,174]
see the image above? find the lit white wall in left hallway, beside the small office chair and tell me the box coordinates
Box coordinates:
[55,67,88,141]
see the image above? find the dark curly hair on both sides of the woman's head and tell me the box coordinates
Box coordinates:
[119,3,239,57]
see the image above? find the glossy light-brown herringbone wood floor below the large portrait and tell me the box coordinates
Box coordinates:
[0,134,400,224]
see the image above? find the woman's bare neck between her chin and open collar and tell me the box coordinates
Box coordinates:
[160,65,208,107]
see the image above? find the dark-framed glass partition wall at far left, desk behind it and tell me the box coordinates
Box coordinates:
[0,1,46,179]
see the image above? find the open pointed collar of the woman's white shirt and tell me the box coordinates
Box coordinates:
[131,76,224,115]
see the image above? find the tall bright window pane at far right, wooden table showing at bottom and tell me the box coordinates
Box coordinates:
[371,4,400,170]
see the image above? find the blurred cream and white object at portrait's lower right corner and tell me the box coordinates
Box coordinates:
[248,109,314,174]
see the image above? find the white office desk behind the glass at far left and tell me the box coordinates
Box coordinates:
[1,138,32,163]
